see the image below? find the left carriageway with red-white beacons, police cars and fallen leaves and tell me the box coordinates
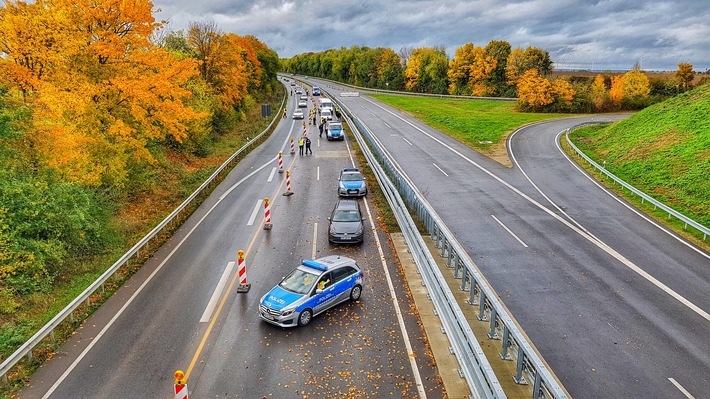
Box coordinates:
[19,79,445,398]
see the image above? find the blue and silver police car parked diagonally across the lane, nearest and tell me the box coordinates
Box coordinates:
[259,255,363,327]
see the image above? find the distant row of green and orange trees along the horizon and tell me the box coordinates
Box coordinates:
[281,40,708,112]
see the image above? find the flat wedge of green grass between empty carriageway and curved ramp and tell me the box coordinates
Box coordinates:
[371,94,571,166]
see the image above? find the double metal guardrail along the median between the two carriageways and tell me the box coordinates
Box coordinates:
[331,96,567,399]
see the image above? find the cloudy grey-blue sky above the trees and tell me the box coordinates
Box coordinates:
[154,0,710,71]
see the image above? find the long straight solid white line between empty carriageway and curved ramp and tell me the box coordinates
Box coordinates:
[365,98,710,321]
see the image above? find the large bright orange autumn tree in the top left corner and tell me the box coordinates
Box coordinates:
[0,0,204,185]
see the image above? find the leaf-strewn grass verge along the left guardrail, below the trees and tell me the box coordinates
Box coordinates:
[0,92,283,399]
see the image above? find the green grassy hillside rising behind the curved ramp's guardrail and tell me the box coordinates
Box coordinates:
[573,84,710,226]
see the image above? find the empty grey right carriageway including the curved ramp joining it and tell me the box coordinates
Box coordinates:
[322,81,710,398]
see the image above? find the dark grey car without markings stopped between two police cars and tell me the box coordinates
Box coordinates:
[328,199,365,244]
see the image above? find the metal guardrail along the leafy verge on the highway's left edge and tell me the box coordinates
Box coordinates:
[0,97,286,382]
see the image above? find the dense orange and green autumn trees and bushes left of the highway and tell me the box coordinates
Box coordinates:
[0,0,280,315]
